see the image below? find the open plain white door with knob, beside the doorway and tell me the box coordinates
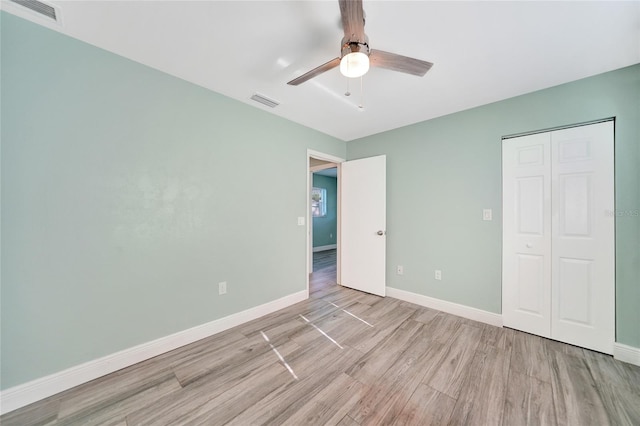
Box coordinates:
[339,155,387,296]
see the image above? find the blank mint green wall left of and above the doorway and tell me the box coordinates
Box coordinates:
[0,13,346,389]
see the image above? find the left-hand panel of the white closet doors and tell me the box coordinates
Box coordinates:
[502,133,551,337]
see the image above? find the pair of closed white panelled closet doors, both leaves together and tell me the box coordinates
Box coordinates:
[502,121,615,354]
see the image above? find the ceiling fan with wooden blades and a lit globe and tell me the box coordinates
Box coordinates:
[287,0,433,86]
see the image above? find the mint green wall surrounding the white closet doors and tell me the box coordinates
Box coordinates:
[347,65,640,347]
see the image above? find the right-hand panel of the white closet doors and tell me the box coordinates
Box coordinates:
[551,121,615,354]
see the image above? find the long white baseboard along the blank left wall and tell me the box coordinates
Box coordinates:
[0,290,309,414]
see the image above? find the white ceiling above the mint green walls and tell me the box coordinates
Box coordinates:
[2,0,640,141]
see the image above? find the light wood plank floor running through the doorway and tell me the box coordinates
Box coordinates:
[0,248,640,426]
